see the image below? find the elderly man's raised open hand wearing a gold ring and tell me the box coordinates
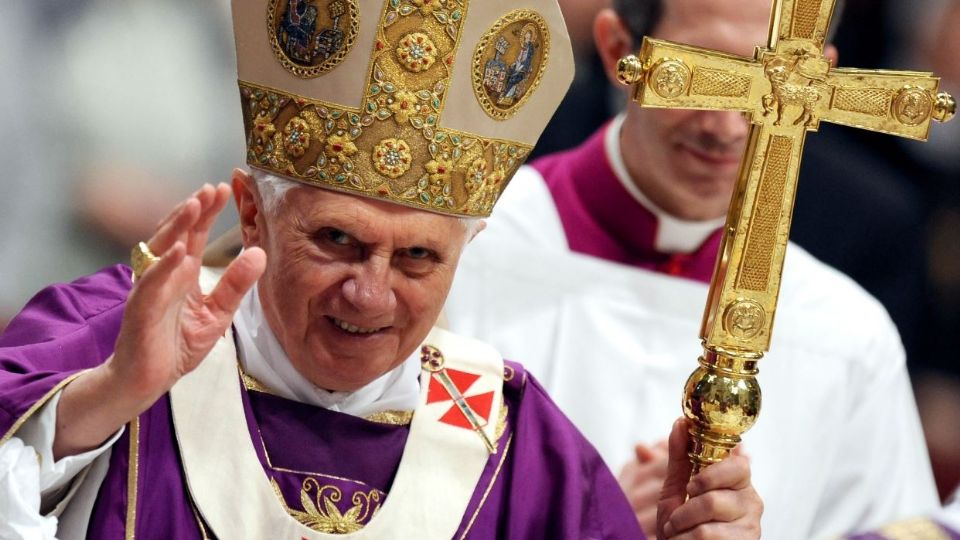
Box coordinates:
[54,184,266,458]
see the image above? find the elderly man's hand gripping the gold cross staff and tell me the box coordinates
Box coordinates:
[657,419,763,540]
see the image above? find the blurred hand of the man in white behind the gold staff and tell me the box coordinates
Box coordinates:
[617,440,667,538]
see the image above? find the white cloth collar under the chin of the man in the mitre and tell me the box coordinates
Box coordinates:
[233,285,420,417]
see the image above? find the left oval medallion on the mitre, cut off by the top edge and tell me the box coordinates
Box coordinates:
[267,0,360,79]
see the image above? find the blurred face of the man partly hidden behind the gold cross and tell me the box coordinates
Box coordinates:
[621,0,770,220]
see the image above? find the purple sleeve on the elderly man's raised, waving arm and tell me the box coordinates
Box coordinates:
[0,266,130,441]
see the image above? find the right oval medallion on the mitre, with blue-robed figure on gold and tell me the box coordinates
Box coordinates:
[473,10,550,120]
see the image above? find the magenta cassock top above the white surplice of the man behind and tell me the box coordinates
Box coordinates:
[531,124,721,283]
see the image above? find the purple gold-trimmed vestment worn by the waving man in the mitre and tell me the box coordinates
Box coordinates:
[0,266,643,540]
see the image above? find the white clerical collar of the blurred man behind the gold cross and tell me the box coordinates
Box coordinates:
[604,113,726,253]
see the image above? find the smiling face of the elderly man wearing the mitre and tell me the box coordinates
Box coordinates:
[235,177,466,391]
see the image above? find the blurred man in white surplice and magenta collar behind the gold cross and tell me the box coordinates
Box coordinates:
[447,0,937,540]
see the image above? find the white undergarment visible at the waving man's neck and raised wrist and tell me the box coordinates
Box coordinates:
[0,287,420,540]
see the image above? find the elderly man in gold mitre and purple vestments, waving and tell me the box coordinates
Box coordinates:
[0,0,761,539]
